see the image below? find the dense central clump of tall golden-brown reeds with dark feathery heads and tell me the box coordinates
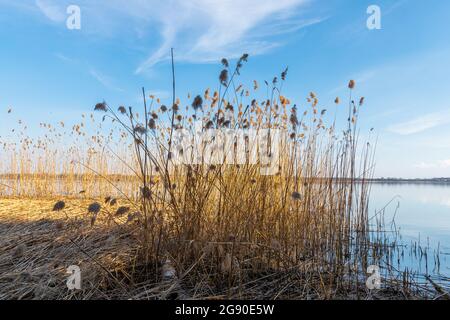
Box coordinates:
[86,54,388,297]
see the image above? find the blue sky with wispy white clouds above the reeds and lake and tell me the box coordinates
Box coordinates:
[0,0,450,177]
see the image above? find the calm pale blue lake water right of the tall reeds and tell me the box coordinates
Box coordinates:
[369,183,450,277]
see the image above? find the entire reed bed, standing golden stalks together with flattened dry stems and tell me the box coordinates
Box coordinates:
[0,55,446,299]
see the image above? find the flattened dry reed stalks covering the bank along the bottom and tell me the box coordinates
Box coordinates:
[0,198,440,300]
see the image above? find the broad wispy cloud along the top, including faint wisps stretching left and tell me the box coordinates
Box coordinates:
[29,0,316,73]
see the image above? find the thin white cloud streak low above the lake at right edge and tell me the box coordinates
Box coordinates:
[387,112,450,135]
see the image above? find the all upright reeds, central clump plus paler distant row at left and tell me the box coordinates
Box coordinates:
[2,55,446,298]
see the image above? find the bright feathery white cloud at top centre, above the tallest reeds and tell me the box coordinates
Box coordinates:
[136,0,312,73]
